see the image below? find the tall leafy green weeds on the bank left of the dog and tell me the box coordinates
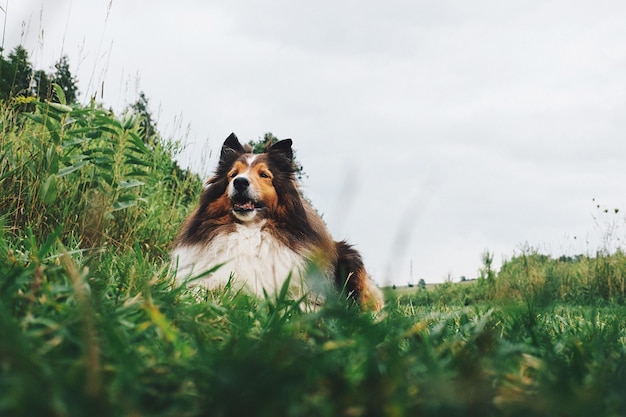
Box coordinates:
[0,96,201,255]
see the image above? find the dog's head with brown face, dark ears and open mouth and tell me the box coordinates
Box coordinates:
[216,134,297,222]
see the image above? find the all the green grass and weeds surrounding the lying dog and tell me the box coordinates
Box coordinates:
[0,95,626,417]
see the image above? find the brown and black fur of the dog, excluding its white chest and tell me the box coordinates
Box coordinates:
[169,134,383,310]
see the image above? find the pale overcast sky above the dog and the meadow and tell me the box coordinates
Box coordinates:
[8,0,626,284]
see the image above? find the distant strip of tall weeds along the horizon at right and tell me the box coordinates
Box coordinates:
[390,244,626,306]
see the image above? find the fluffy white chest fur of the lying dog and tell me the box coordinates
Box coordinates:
[172,221,307,296]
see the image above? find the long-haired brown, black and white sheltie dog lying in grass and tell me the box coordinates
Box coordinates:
[172,134,383,310]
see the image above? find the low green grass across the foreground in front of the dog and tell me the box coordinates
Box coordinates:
[0,229,626,416]
